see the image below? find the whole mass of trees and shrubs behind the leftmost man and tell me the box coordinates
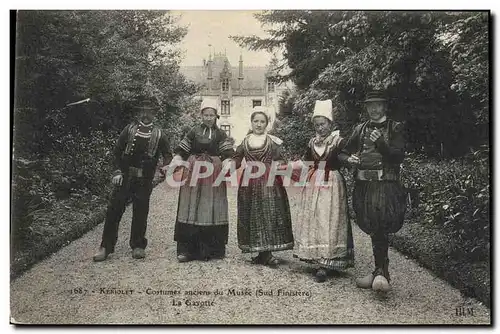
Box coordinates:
[12,10,195,247]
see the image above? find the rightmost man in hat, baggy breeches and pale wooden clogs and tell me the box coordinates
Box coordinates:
[339,91,406,292]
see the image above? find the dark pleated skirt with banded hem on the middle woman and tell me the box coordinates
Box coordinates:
[237,177,294,253]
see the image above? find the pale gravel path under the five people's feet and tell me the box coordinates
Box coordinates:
[11,183,491,324]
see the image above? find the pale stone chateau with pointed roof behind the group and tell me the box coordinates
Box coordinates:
[181,53,286,145]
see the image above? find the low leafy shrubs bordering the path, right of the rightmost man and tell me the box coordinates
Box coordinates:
[402,149,490,261]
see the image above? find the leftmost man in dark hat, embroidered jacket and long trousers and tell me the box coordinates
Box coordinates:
[94,98,172,262]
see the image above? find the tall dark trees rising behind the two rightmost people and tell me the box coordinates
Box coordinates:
[233,10,489,156]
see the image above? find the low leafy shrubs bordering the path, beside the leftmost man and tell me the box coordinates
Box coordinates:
[12,131,116,246]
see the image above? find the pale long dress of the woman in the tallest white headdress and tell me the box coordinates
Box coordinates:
[294,132,354,270]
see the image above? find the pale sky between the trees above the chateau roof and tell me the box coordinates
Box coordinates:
[173,10,272,66]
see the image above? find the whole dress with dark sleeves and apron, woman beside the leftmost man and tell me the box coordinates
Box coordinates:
[174,124,234,259]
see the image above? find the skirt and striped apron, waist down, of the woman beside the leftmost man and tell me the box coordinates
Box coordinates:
[174,155,229,258]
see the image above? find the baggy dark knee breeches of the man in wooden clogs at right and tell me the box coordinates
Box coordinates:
[352,181,406,234]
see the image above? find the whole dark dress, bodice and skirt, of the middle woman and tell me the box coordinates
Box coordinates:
[233,135,294,253]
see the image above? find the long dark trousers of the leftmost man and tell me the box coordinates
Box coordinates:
[101,175,153,253]
